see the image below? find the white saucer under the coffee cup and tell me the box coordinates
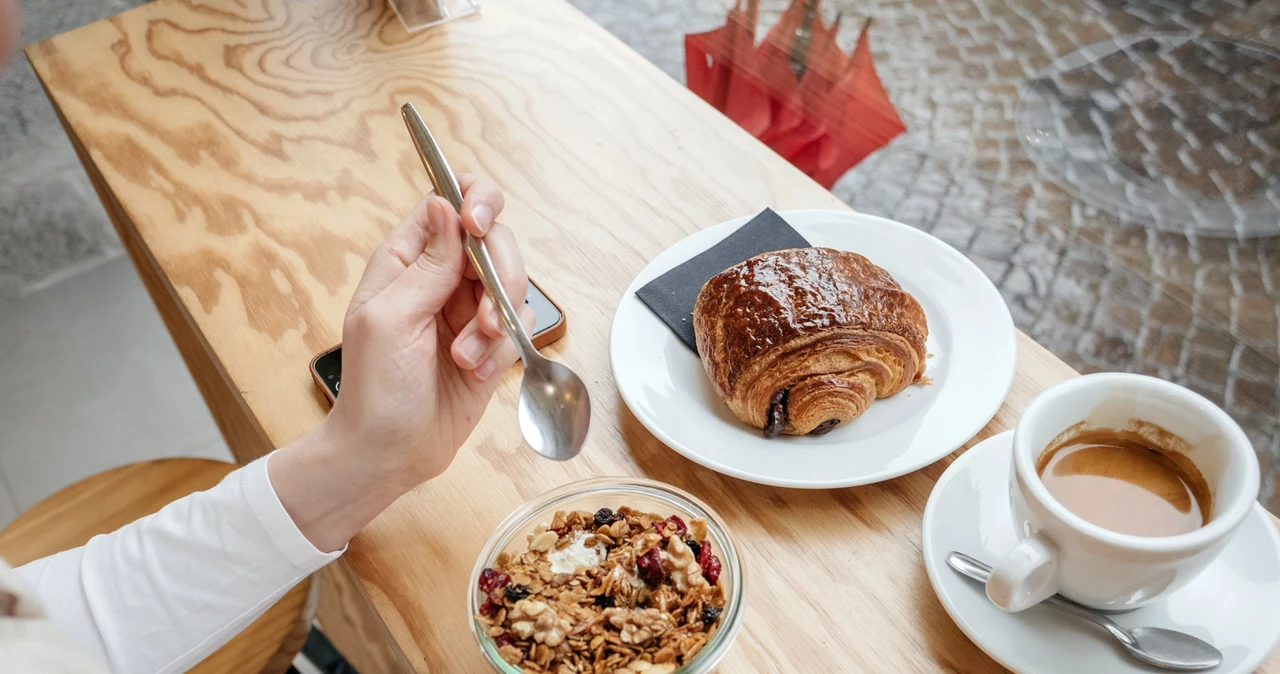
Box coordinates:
[923,431,1280,674]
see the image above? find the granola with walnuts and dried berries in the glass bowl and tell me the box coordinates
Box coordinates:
[476,506,726,674]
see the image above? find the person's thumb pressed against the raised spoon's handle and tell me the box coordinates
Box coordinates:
[383,197,463,317]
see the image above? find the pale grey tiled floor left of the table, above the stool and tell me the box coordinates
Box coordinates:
[0,257,232,526]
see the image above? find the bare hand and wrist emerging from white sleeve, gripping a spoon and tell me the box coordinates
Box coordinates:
[268,175,534,550]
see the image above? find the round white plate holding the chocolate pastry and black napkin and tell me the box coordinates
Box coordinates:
[609,211,1018,489]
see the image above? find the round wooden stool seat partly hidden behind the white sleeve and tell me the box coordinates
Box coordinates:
[0,459,320,674]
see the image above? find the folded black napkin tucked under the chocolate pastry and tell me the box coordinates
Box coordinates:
[636,208,809,353]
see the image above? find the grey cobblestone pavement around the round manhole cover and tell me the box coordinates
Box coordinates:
[571,0,1280,513]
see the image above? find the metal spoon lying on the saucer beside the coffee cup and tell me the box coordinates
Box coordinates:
[947,553,1222,671]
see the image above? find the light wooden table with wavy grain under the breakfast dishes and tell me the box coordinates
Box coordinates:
[28,0,1280,673]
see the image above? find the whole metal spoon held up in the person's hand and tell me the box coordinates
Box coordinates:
[401,104,591,460]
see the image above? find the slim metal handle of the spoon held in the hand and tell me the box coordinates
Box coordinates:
[401,104,538,363]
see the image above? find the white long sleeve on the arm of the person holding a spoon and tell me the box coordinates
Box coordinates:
[0,457,342,674]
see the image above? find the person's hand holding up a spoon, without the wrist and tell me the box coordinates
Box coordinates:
[326,175,534,485]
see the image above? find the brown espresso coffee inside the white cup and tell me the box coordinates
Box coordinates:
[1036,430,1212,536]
